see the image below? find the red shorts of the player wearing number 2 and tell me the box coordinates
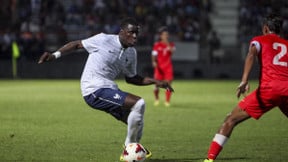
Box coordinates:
[238,81,288,119]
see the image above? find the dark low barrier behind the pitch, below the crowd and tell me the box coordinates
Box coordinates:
[0,50,258,79]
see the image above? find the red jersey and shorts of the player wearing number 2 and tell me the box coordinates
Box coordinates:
[239,34,288,119]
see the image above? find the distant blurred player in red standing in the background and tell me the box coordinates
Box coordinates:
[152,26,175,107]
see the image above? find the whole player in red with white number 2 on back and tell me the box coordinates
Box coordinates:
[204,14,288,162]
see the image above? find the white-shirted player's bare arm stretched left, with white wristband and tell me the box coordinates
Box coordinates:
[38,40,83,64]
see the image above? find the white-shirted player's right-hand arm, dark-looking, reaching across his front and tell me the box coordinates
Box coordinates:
[125,75,174,92]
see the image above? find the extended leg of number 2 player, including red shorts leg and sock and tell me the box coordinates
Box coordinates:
[207,88,280,161]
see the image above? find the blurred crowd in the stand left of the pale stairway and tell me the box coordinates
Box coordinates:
[0,0,211,59]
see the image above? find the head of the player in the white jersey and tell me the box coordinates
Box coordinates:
[119,17,140,48]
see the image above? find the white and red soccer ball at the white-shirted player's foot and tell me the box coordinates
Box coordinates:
[123,143,146,162]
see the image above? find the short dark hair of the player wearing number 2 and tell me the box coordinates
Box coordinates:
[263,13,283,34]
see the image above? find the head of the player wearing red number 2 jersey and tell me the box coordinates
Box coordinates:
[262,13,283,34]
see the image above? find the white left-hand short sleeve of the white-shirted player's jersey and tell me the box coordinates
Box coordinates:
[81,33,104,53]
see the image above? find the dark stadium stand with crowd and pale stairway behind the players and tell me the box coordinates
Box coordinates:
[0,0,288,78]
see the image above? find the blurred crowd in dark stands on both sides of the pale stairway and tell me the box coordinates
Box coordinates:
[0,0,288,64]
